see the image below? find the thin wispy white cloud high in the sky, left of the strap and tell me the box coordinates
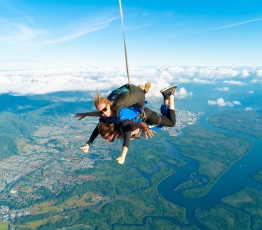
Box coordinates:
[0,13,119,48]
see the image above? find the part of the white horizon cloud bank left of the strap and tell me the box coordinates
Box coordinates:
[0,68,123,95]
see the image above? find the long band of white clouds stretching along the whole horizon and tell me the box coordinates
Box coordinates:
[0,67,262,97]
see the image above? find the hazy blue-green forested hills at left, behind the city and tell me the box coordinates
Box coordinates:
[0,94,93,160]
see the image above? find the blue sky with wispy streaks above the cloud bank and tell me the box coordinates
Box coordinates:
[0,0,262,70]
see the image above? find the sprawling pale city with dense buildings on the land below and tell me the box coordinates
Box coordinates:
[0,110,200,222]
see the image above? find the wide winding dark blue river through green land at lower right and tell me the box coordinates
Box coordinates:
[158,111,262,230]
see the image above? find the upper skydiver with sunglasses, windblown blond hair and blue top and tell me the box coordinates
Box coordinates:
[76,85,177,164]
